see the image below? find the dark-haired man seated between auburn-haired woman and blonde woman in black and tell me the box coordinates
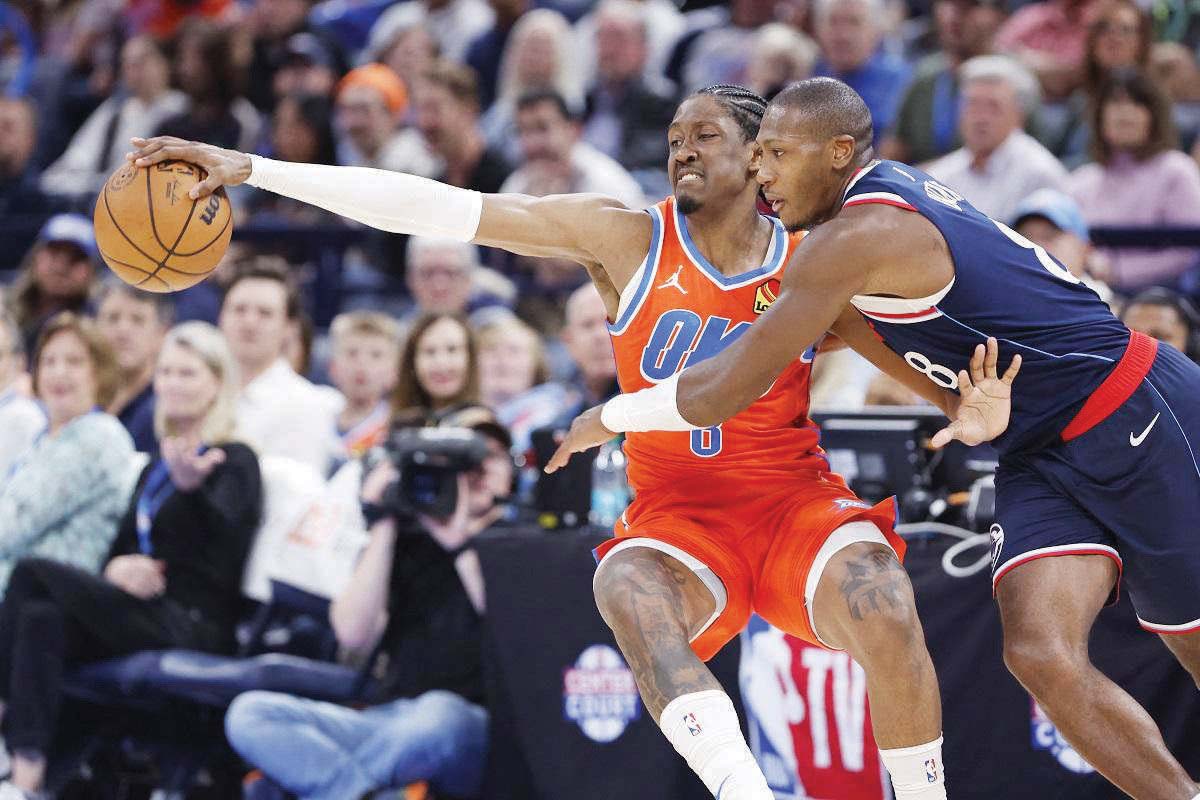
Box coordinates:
[96,283,172,455]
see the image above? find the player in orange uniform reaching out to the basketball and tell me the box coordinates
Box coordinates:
[133,86,1010,800]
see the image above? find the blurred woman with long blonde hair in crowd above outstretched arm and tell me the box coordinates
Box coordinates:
[480,8,583,163]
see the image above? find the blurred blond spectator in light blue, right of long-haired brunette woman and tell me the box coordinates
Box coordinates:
[475,314,569,452]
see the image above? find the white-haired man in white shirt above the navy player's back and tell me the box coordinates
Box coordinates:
[928,55,1067,221]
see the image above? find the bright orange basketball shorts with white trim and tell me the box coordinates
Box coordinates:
[595,469,905,661]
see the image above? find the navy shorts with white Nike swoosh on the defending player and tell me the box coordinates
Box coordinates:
[992,344,1200,633]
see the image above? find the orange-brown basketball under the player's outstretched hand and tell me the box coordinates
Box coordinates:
[94,161,233,291]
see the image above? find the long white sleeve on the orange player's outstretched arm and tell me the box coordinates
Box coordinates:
[246,155,484,242]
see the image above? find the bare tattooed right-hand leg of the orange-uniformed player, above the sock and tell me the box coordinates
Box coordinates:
[812,542,942,750]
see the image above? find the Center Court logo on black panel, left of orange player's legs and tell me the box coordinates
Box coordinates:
[563,644,642,744]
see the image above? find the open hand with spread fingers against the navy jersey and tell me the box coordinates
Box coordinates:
[930,337,1021,447]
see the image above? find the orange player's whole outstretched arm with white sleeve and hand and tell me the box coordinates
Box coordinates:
[128,137,650,291]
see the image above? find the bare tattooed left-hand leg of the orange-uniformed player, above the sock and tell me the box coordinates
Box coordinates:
[595,547,721,720]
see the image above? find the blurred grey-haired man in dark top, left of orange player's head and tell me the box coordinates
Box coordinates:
[581,0,676,179]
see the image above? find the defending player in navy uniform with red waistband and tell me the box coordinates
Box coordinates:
[553,79,1200,800]
